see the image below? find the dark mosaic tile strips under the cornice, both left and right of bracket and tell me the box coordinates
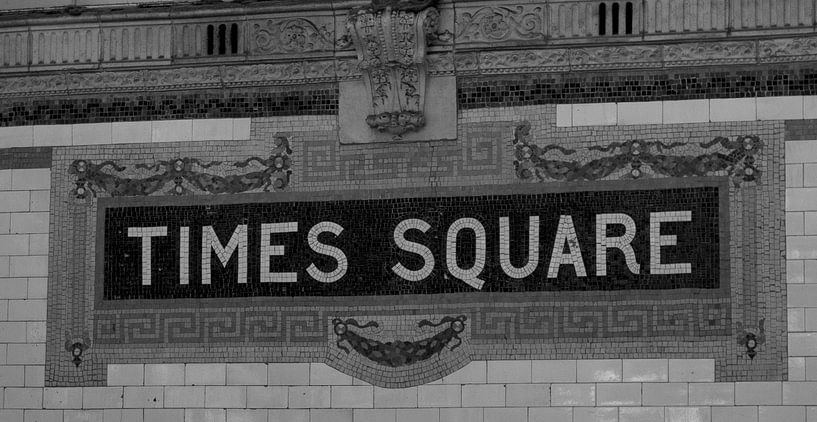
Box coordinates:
[0,64,817,126]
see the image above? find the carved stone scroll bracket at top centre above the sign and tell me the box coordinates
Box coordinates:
[338,0,440,136]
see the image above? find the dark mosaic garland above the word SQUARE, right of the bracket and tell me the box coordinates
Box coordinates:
[513,121,764,185]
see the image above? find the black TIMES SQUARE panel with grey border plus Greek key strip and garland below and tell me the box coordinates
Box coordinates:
[81,178,729,386]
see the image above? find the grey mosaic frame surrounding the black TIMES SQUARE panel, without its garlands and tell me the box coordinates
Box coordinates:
[46,117,787,387]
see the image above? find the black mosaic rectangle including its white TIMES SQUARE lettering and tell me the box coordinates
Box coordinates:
[102,186,721,301]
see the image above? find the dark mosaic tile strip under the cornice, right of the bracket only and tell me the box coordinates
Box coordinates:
[457,65,817,109]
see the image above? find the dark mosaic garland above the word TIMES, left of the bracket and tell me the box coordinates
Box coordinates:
[68,137,292,199]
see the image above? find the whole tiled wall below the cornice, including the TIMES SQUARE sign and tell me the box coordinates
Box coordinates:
[0,97,817,421]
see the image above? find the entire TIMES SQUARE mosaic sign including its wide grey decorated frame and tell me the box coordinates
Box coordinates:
[46,123,786,388]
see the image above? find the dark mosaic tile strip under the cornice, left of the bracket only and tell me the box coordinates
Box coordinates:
[0,85,338,127]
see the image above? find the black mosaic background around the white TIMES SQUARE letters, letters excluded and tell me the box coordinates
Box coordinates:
[104,187,720,300]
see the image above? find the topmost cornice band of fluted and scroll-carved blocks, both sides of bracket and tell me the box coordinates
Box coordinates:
[0,0,817,74]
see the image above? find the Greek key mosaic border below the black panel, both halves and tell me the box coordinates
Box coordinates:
[94,298,731,346]
